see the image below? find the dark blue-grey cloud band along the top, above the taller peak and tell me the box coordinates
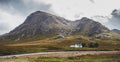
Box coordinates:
[0,0,51,15]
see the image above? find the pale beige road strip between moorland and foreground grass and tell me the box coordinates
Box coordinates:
[0,51,120,58]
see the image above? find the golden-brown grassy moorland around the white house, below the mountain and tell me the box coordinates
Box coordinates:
[0,35,120,55]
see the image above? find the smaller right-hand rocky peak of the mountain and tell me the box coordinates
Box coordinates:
[75,17,110,36]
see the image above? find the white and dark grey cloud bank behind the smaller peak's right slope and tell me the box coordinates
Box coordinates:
[92,9,120,29]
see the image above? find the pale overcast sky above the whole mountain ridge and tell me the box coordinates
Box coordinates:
[0,0,120,34]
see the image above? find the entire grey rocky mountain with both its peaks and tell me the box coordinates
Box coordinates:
[0,11,109,41]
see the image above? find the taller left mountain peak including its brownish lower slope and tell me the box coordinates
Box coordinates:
[2,11,70,41]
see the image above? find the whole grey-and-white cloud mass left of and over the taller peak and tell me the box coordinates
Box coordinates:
[0,0,51,34]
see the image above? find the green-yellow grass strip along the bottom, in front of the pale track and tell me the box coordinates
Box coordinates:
[0,54,120,62]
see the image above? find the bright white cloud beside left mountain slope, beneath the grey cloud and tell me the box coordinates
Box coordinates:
[0,10,24,33]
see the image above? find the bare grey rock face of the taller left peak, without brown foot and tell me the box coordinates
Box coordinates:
[10,11,70,36]
